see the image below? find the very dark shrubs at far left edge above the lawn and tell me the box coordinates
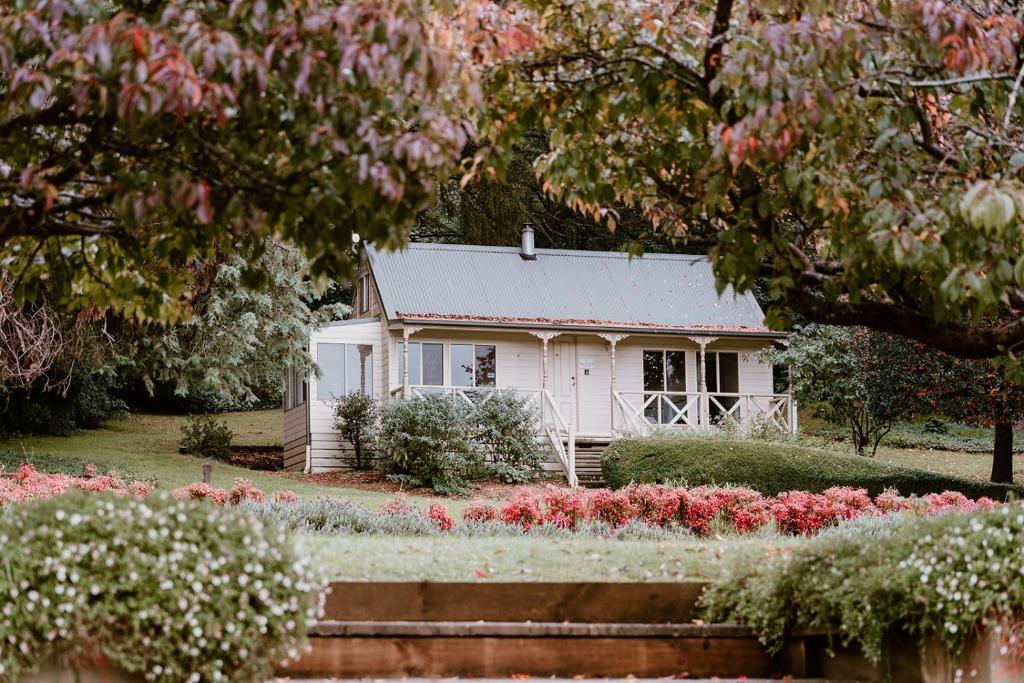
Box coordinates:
[0,368,128,436]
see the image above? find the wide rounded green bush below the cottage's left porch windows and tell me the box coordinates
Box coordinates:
[377,394,485,494]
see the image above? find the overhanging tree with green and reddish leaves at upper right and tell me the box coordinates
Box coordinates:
[487,0,1024,368]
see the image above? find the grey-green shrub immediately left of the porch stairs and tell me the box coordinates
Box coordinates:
[470,391,542,483]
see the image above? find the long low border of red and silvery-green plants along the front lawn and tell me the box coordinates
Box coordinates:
[258,484,996,538]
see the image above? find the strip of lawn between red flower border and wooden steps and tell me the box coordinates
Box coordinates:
[299,535,778,581]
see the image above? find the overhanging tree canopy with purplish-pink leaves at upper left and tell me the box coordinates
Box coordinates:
[0,0,476,319]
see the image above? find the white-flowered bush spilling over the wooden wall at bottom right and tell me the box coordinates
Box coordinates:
[701,504,1024,661]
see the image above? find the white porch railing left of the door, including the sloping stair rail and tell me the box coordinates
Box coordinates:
[390,385,579,486]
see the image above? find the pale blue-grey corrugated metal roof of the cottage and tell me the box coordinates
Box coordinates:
[367,244,767,332]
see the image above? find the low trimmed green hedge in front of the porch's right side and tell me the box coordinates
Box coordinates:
[601,437,1024,500]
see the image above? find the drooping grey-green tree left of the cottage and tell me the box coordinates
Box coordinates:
[112,242,349,410]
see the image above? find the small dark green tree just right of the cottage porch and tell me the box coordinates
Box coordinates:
[772,325,918,456]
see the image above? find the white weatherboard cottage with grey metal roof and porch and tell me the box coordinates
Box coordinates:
[285,226,797,484]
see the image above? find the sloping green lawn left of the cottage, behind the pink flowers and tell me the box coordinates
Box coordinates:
[0,410,436,508]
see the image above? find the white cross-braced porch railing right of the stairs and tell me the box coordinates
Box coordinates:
[612,391,796,436]
